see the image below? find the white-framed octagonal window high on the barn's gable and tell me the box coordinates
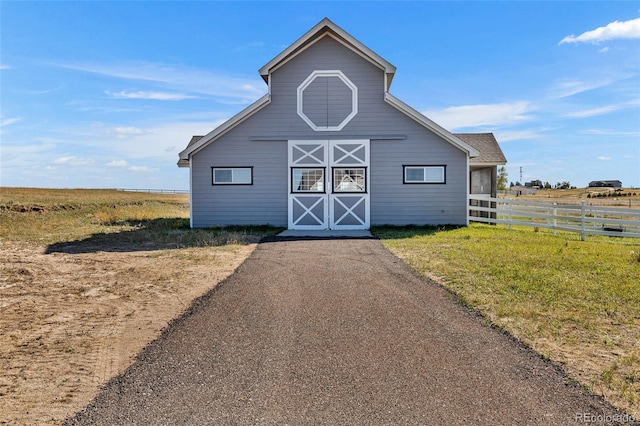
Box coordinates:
[298,71,358,131]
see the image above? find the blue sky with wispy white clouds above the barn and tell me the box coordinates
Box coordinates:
[0,1,640,189]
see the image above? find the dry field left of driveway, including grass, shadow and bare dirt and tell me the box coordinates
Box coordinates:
[0,188,276,425]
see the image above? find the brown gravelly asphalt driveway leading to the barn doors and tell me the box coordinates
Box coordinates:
[67,239,623,425]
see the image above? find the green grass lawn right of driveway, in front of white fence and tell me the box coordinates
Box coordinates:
[372,224,640,416]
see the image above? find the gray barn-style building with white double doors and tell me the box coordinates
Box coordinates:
[178,19,506,230]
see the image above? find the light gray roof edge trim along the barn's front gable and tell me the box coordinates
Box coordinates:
[178,18,480,167]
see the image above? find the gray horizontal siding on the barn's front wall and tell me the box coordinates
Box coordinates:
[192,38,467,227]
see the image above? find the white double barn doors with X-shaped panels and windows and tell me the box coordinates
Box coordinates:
[288,140,370,230]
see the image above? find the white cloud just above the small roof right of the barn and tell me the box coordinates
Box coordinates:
[423,101,535,130]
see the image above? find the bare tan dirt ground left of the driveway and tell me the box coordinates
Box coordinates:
[0,241,255,425]
